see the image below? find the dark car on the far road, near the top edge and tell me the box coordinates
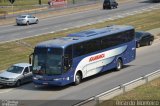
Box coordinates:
[103,0,118,9]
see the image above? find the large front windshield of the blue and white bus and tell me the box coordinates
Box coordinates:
[33,48,63,75]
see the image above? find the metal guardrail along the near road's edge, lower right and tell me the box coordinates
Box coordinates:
[74,69,160,106]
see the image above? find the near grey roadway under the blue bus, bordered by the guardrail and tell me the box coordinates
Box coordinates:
[0,41,160,106]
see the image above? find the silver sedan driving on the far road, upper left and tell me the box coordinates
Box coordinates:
[16,15,39,25]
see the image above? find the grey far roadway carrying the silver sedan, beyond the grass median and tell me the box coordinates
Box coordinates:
[0,0,160,43]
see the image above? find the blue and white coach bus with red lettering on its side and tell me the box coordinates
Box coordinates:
[30,25,136,86]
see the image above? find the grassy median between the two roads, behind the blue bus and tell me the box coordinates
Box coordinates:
[0,9,160,70]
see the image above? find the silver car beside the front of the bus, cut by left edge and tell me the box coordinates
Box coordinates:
[0,63,32,87]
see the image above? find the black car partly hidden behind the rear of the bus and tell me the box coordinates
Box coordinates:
[135,31,154,48]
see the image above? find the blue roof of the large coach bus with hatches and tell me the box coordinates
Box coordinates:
[36,25,134,48]
